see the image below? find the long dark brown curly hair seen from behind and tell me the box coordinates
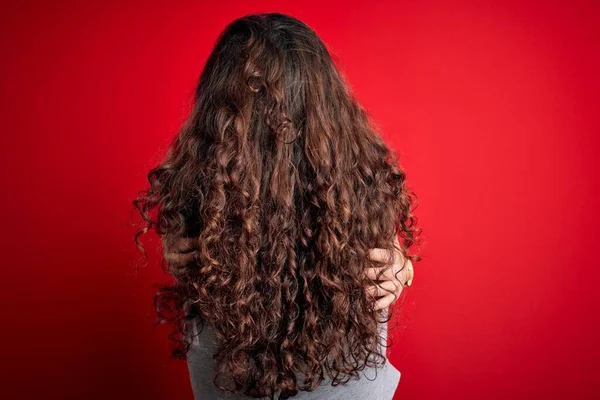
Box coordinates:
[133,13,420,399]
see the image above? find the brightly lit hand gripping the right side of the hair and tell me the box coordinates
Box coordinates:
[366,237,414,310]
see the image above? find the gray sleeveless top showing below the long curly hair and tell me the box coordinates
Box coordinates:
[187,316,400,400]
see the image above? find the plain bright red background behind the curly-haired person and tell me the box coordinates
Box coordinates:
[0,0,600,400]
